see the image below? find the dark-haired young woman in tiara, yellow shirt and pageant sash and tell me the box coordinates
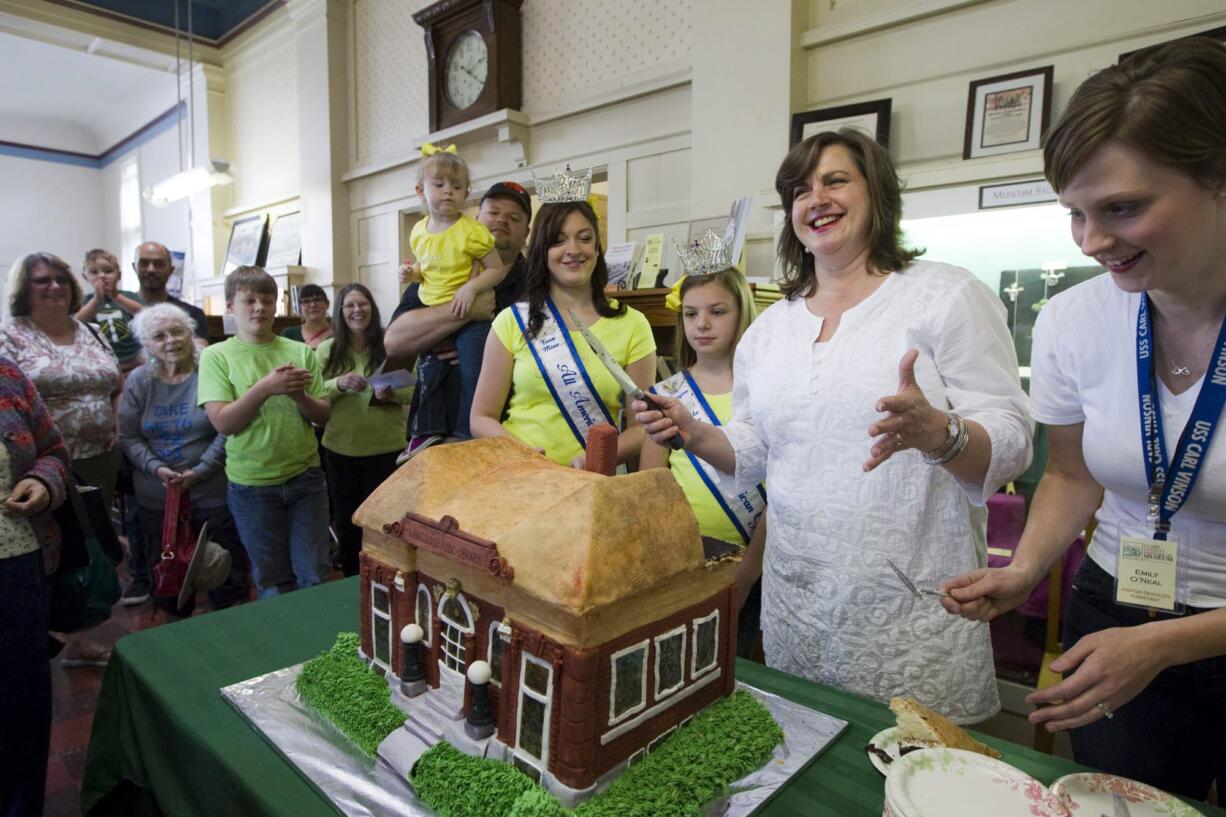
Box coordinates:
[471,185,656,469]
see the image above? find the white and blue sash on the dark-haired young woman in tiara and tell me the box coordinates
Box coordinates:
[511,297,617,447]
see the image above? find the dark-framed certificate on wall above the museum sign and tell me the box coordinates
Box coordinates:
[962,65,1053,159]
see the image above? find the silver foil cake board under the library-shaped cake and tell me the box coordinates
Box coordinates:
[221,664,847,817]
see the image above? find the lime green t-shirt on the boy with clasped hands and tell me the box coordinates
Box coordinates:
[196,337,324,486]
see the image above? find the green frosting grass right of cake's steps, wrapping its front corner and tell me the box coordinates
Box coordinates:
[413,691,783,817]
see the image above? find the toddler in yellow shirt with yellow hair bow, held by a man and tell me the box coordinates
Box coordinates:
[402,144,506,454]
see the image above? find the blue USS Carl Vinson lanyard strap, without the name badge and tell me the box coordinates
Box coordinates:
[1137,293,1226,540]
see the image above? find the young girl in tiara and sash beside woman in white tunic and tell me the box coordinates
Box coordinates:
[639,267,766,658]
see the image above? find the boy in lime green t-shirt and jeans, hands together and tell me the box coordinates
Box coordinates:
[196,266,331,599]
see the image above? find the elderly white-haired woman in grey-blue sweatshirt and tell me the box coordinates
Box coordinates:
[119,303,248,617]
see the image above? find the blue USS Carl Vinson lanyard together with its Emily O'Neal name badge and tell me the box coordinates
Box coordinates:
[1116,294,1226,613]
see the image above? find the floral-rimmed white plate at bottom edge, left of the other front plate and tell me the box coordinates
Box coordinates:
[883,747,1073,817]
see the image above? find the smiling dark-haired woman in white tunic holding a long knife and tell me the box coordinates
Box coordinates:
[635,130,1031,723]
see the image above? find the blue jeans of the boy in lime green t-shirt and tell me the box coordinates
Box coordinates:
[226,467,331,599]
